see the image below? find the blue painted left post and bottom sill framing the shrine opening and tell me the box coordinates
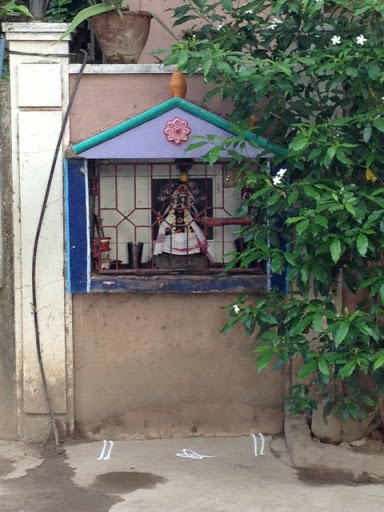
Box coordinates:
[65,159,280,294]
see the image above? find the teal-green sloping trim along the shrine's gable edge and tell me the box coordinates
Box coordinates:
[72,98,288,156]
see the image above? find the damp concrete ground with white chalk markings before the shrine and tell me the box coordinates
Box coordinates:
[0,436,384,512]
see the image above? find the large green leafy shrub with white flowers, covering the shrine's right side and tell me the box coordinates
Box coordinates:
[165,0,384,419]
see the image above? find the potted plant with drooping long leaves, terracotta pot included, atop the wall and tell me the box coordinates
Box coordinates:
[60,0,176,64]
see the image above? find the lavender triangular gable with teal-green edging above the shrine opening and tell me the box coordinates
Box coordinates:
[72,98,287,158]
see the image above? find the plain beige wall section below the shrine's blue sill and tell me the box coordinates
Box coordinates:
[73,294,283,439]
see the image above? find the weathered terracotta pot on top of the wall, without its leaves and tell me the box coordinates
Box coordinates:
[92,11,152,64]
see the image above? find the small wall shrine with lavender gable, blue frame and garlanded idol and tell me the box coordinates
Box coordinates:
[66,86,281,292]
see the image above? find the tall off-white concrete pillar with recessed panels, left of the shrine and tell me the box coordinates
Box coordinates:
[3,23,73,440]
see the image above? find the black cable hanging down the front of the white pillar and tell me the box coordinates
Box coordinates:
[32,50,88,445]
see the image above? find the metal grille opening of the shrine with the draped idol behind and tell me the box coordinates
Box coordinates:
[90,160,263,274]
